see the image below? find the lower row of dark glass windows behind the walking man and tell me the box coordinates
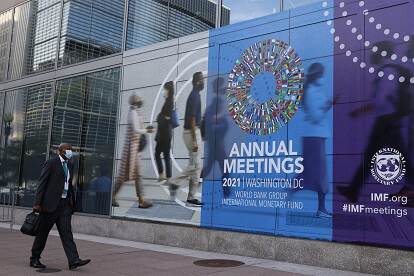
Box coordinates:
[0,68,120,214]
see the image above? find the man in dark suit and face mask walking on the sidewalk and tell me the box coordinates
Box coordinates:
[30,144,91,270]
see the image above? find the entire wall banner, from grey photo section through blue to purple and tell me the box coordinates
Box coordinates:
[113,0,414,249]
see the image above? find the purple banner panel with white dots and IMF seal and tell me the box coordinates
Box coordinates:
[332,0,414,249]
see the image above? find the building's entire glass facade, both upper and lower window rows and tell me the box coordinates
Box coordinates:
[0,0,330,215]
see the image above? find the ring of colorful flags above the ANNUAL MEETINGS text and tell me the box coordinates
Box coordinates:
[227,39,304,135]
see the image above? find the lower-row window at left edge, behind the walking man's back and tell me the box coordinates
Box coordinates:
[0,83,52,207]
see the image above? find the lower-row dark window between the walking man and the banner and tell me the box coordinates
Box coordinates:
[51,68,120,214]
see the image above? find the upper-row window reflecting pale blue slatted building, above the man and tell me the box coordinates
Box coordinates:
[59,0,125,66]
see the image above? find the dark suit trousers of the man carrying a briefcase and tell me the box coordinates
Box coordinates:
[31,198,79,265]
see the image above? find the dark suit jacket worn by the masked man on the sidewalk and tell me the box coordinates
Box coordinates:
[34,156,75,213]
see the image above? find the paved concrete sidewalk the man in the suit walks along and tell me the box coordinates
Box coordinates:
[0,225,376,276]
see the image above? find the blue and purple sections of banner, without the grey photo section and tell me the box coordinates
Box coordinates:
[201,0,414,248]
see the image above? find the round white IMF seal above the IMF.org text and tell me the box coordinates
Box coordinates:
[371,148,406,186]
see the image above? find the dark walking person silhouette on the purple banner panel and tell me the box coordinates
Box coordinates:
[337,41,414,202]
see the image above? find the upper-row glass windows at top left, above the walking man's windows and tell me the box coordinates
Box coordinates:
[0,0,125,81]
